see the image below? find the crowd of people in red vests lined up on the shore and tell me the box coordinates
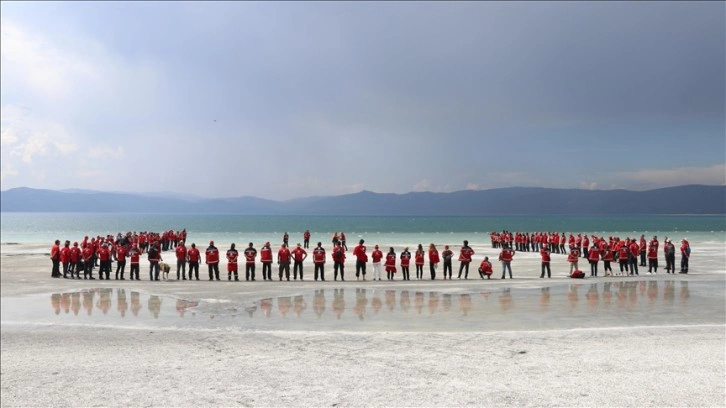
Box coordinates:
[50,229,691,281]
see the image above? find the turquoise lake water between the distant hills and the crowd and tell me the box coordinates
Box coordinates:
[0,213,726,245]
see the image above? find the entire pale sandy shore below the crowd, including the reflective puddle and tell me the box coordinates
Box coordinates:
[0,245,726,406]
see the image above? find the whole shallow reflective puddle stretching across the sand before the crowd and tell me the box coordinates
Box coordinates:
[2,280,726,332]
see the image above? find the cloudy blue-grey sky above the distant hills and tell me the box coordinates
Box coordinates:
[0,2,726,200]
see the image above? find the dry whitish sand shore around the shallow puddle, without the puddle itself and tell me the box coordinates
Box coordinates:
[0,244,726,406]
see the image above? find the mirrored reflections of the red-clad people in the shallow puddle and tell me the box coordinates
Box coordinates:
[42,280,704,321]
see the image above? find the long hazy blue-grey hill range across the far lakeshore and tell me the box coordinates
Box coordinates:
[0,185,726,216]
